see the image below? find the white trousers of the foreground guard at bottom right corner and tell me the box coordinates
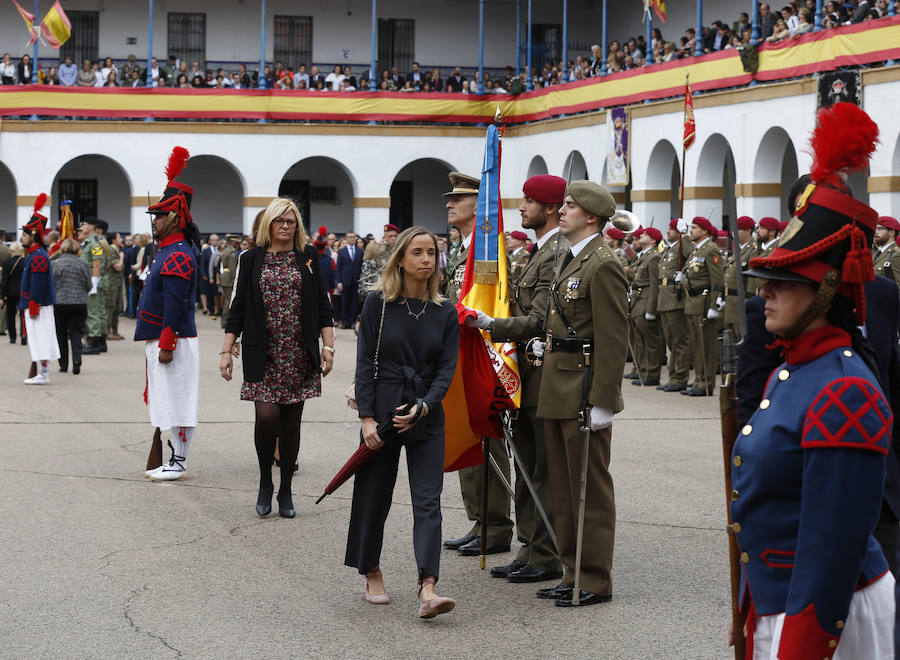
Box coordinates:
[753,573,895,660]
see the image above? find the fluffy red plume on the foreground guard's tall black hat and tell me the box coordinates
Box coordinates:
[809,103,878,190]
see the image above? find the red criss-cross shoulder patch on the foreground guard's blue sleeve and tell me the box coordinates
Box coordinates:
[801,377,893,454]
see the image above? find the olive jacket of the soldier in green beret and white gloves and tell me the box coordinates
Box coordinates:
[537,234,628,419]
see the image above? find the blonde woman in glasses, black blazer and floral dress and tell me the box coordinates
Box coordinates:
[219,197,334,518]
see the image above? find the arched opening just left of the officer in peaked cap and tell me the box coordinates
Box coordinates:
[390,158,454,234]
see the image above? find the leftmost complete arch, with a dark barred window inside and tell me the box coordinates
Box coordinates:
[50,154,131,233]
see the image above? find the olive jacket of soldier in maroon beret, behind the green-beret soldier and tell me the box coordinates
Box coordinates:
[491,232,569,408]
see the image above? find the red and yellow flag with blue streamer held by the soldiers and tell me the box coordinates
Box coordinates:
[444,124,522,472]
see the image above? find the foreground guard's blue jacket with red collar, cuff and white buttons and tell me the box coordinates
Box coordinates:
[731,326,892,658]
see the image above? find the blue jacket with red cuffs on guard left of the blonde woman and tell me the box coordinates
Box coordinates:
[134,233,197,351]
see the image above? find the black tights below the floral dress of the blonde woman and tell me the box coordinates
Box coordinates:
[253,401,303,493]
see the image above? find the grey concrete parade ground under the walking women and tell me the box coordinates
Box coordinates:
[0,316,731,659]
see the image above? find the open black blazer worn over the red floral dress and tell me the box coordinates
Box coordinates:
[225,246,334,383]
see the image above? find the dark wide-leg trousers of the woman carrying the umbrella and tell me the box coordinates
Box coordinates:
[344,424,444,580]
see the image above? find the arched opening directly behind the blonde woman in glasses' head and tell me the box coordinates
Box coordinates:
[278,156,356,234]
